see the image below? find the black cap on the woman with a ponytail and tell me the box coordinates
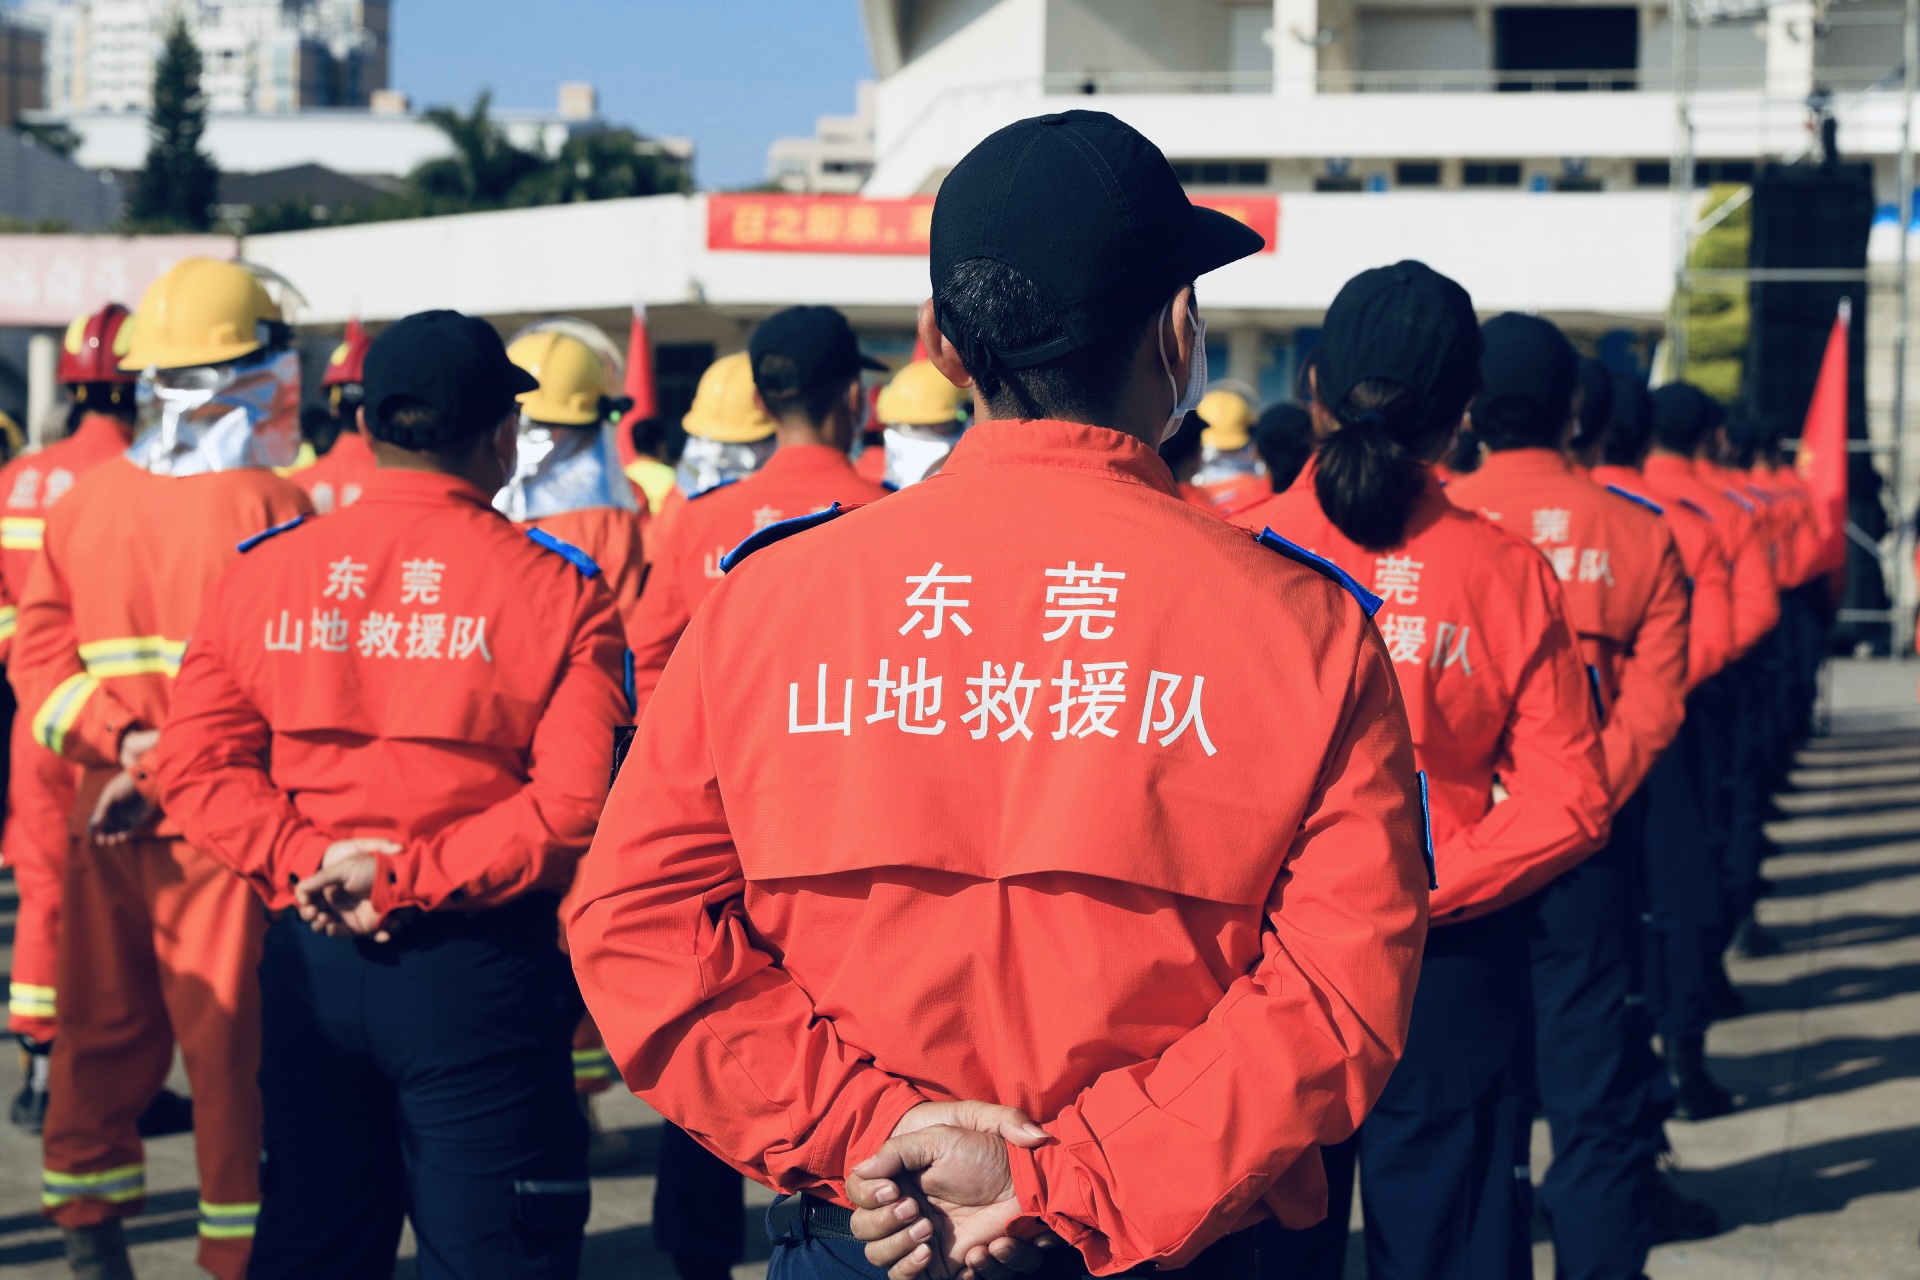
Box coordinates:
[1313,259,1482,420]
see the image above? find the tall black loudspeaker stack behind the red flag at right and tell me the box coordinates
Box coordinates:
[1741,163,1891,652]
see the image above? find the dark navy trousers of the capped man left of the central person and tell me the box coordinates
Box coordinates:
[248,894,589,1280]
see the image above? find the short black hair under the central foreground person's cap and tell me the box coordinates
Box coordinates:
[933,257,1165,422]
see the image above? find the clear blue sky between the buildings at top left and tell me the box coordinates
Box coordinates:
[392,0,872,186]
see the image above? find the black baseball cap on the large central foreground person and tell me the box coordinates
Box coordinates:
[929,111,1265,368]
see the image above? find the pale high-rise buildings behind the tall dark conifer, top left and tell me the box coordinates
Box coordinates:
[17,0,392,115]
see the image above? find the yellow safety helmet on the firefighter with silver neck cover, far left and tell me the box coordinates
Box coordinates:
[121,257,284,370]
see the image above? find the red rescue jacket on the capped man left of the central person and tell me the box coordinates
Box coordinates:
[154,468,628,912]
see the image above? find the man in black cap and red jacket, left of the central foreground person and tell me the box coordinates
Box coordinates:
[154,311,628,1278]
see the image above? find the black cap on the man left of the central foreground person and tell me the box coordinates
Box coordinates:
[365,311,540,449]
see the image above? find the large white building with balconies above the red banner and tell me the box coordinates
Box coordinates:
[862,0,1901,196]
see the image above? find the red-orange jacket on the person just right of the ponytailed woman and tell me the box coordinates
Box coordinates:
[1446,449,1688,808]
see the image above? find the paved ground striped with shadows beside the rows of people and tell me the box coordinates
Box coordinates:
[0,662,1920,1280]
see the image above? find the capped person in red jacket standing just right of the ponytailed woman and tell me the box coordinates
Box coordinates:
[1446,313,1688,1280]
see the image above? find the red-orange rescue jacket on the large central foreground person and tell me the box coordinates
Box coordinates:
[570,422,1427,1274]
